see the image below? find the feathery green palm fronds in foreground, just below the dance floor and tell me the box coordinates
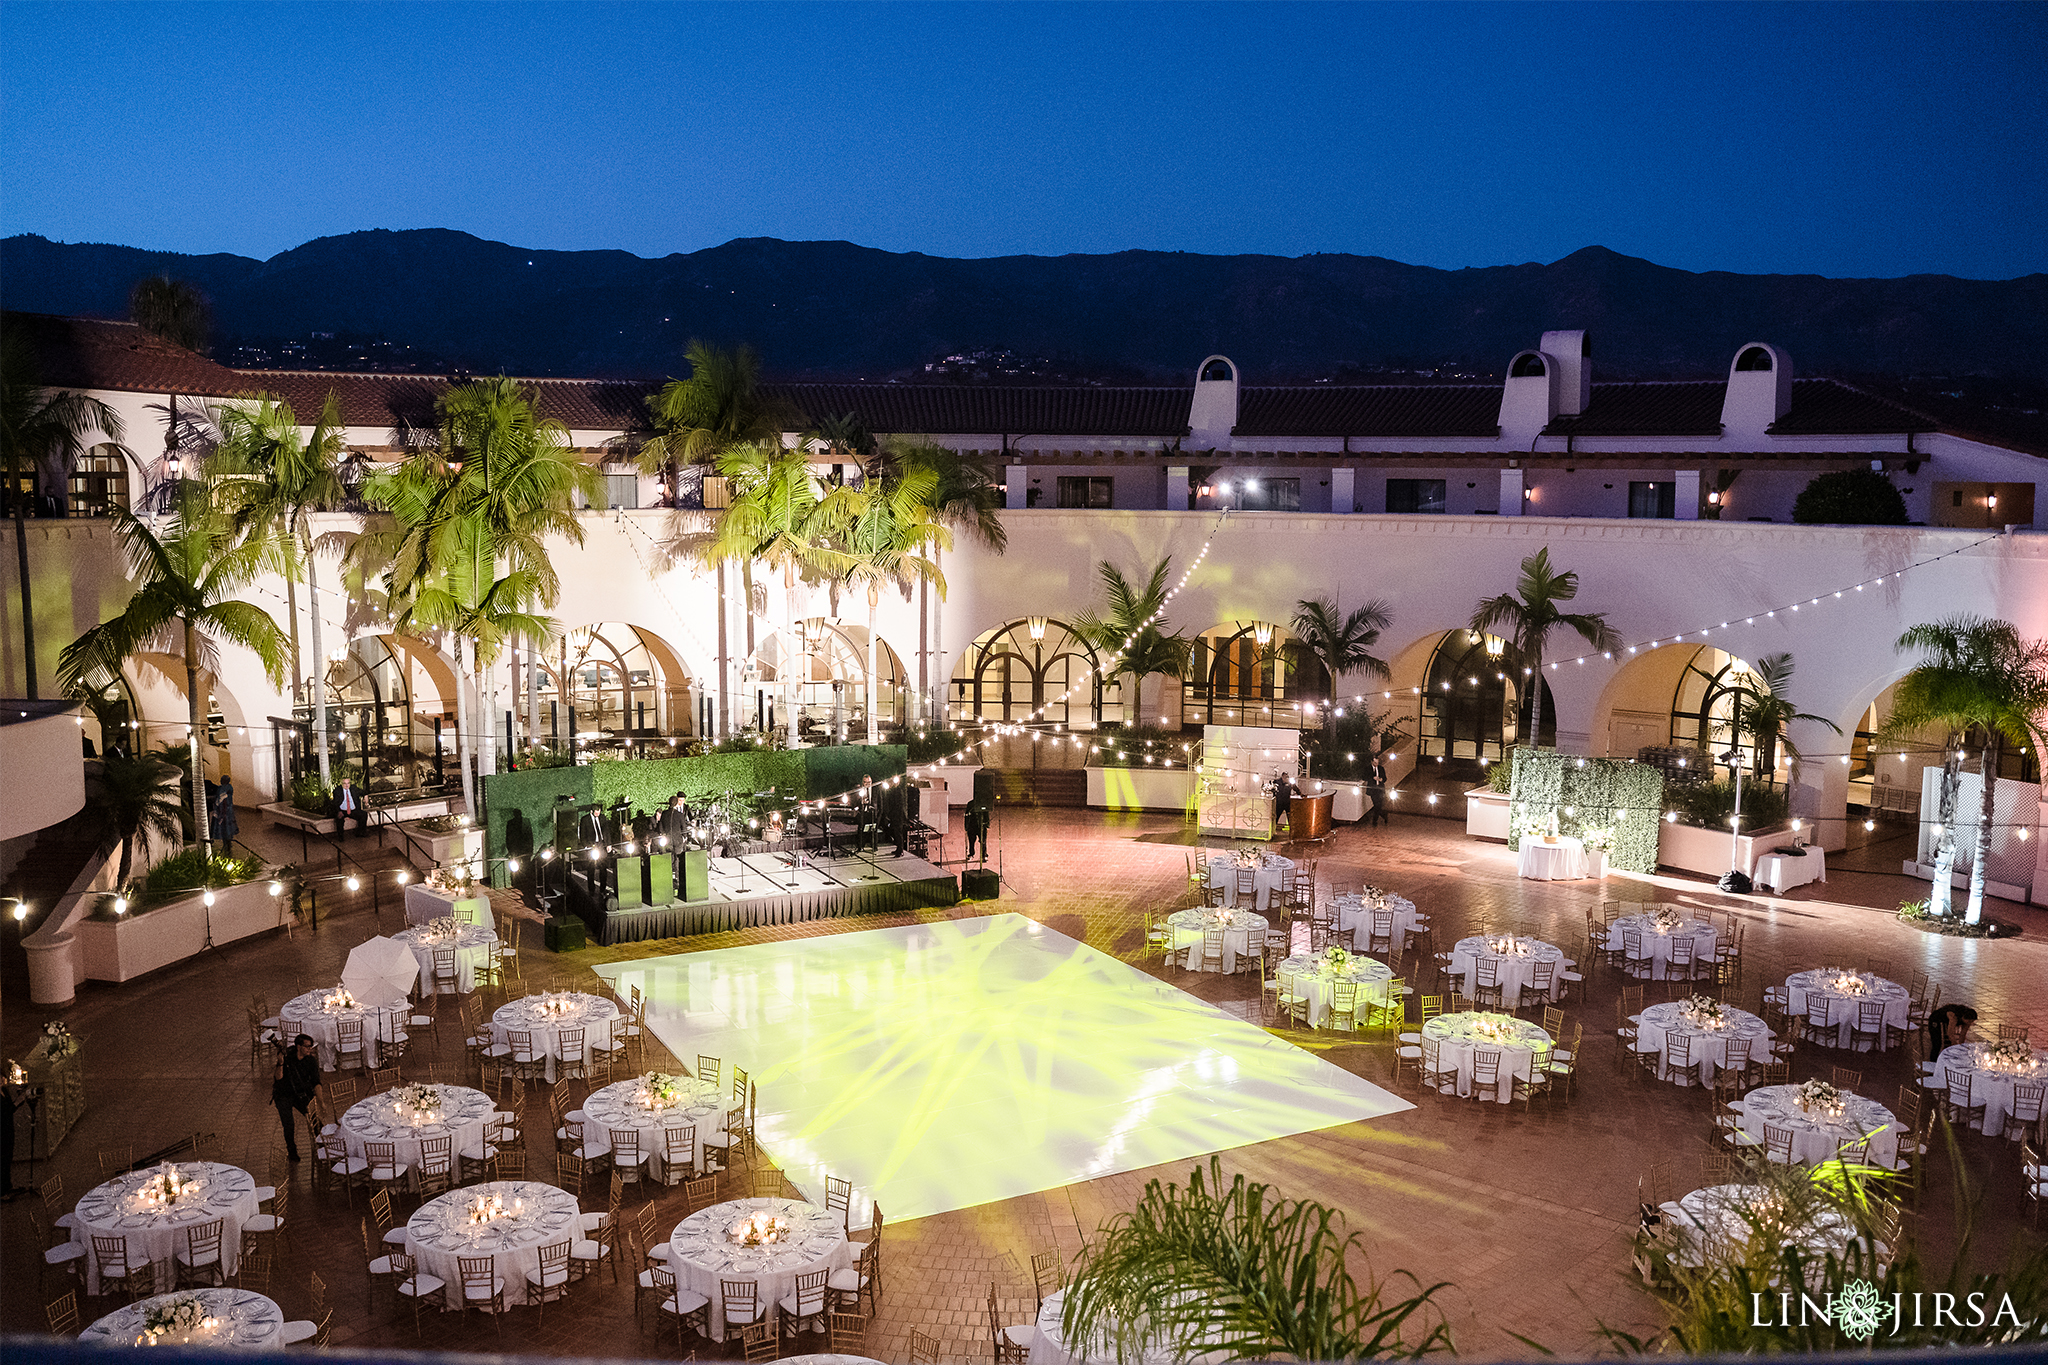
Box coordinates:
[1061,1156,1452,1361]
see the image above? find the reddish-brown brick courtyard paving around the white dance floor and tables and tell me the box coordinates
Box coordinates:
[0,810,2048,1359]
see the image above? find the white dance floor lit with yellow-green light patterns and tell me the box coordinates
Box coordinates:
[598,915,1411,1220]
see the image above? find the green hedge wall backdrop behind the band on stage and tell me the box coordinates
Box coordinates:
[483,745,909,886]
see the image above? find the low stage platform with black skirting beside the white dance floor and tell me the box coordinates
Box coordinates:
[584,853,961,943]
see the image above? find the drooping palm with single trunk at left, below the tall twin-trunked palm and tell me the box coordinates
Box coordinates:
[57,489,291,855]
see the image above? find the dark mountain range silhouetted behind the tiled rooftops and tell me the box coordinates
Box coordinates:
[0,229,2048,383]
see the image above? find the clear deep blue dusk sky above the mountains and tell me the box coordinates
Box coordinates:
[0,0,2048,278]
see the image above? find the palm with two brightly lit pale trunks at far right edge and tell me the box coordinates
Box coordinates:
[1878,616,2048,925]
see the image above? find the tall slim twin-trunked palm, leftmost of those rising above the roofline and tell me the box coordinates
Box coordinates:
[209,389,346,788]
